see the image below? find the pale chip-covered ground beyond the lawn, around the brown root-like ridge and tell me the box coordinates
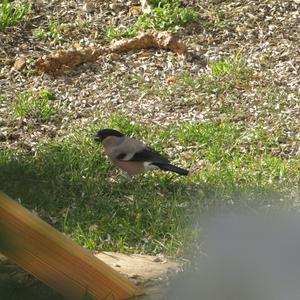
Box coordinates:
[0,0,300,157]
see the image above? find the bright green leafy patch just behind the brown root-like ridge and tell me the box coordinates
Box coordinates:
[106,1,198,41]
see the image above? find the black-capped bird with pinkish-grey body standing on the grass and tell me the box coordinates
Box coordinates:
[95,128,189,176]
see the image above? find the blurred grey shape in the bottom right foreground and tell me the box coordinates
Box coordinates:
[167,212,300,300]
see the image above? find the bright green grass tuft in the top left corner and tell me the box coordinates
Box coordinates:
[0,0,31,31]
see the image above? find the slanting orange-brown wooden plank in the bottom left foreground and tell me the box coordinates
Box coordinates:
[0,193,141,300]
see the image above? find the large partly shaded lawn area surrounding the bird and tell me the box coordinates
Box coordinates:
[0,117,300,256]
